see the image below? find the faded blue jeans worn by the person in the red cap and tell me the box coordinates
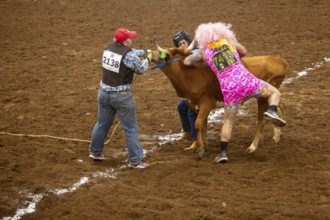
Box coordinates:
[89,88,143,164]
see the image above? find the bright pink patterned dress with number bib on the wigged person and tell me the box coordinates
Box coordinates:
[203,39,268,110]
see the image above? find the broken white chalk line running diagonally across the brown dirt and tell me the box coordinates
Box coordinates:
[1,58,330,220]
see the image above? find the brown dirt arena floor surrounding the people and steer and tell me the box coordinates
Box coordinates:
[0,0,330,219]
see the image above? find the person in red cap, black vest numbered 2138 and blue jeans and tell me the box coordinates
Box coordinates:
[89,29,152,168]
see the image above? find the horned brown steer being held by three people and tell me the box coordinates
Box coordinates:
[152,39,288,159]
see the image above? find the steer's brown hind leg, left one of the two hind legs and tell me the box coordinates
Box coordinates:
[246,97,268,153]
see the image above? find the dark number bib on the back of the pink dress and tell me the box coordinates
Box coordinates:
[212,44,237,71]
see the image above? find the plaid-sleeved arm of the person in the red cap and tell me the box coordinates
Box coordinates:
[123,50,149,75]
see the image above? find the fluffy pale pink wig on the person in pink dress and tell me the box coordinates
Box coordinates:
[195,22,236,47]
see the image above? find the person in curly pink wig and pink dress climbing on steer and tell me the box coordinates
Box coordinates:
[184,22,286,163]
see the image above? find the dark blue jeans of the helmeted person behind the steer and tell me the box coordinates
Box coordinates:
[177,100,197,140]
